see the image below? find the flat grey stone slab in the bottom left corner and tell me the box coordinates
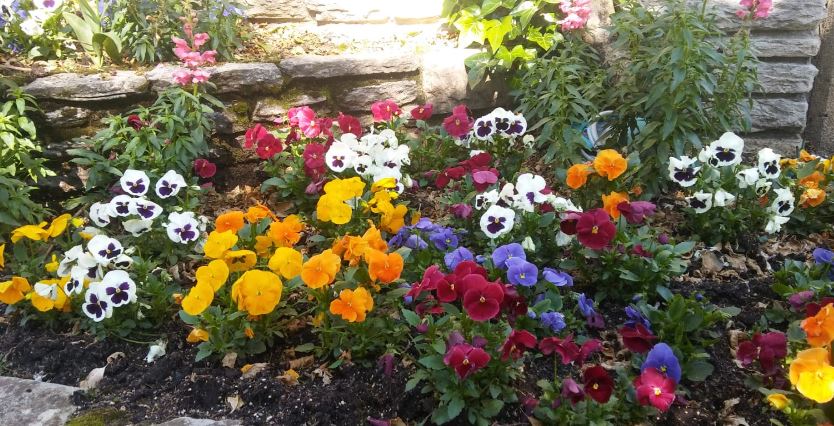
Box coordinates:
[0,377,80,426]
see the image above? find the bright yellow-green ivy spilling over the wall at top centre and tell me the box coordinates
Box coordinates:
[443,0,562,86]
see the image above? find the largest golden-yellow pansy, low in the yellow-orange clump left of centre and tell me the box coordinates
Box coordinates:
[232,269,284,315]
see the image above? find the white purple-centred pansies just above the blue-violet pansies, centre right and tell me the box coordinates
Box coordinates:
[475,173,578,239]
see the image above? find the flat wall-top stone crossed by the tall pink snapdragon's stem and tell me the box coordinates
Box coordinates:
[145,62,284,94]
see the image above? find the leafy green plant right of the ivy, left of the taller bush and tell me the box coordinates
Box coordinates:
[513,36,607,166]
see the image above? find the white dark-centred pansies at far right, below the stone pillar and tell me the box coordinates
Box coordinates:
[669,132,796,233]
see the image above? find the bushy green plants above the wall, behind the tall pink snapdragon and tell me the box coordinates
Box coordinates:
[113,0,245,64]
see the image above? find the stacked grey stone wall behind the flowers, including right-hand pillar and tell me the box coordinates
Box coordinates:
[25,0,826,166]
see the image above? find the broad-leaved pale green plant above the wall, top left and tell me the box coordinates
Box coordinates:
[63,0,122,67]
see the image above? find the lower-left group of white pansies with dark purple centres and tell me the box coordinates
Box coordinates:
[51,234,136,322]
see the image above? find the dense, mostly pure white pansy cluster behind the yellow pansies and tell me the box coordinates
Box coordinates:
[325,129,411,192]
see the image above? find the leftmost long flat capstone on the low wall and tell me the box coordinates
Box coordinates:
[23,71,148,102]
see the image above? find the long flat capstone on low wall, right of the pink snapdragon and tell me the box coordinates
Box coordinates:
[279,53,419,79]
